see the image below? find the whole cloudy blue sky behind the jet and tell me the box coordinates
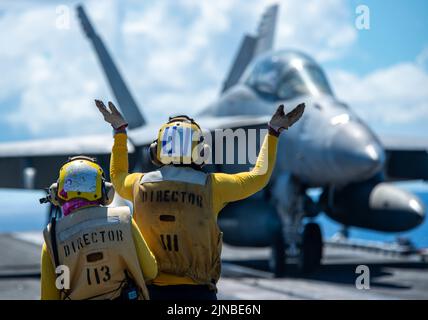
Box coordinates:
[0,0,428,142]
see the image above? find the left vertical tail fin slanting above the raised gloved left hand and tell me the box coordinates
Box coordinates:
[77,5,146,129]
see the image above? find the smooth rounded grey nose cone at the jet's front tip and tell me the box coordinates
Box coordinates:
[331,123,385,181]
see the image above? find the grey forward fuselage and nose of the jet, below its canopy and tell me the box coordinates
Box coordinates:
[201,85,385,187]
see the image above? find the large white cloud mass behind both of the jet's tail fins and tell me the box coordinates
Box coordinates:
[0,0,356,137]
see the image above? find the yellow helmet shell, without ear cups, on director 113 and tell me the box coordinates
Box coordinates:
[57,156,105,201]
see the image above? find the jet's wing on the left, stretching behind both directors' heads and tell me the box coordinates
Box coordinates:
[0,116,269,189]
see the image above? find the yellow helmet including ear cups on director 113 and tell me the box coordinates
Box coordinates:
[49,156,114,205]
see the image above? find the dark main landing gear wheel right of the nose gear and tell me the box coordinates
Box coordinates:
[298,222,323,273]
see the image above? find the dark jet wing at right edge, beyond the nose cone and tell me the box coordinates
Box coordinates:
[379,135,428,181]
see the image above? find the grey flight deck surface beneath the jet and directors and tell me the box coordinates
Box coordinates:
[0,233,428,300]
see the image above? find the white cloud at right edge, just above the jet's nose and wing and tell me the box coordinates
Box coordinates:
[330,58,428,128]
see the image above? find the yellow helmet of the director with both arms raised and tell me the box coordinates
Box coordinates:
[150,115,204,165]
